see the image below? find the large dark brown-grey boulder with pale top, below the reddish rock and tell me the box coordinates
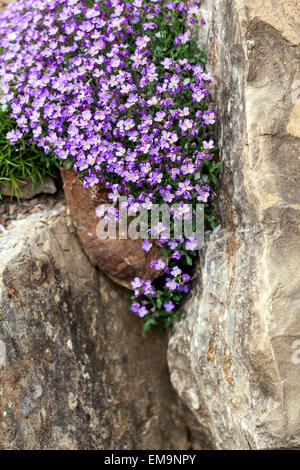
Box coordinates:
[0,205,189,450]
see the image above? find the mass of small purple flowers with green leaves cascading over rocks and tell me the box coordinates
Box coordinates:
[0,0,218,329]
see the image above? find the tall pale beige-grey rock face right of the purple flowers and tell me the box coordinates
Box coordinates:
[168,0,300,449]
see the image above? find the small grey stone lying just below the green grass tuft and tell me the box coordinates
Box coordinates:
[0,176,57,199]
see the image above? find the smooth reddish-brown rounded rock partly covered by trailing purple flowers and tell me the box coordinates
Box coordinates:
[61,167,161,289]
